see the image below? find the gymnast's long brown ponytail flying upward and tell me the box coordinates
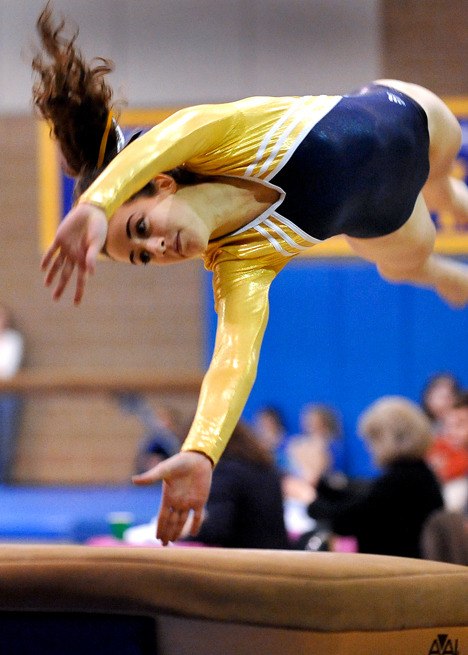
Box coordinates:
[32,3,118,177]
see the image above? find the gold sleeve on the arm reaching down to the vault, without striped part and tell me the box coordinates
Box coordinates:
[182,260,276,465]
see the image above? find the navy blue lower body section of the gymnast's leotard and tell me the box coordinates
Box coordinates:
[270,85,429,239]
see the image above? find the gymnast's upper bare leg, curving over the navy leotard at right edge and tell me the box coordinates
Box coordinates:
[377,80,468,225]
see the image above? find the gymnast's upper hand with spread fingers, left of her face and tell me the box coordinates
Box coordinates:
[41,203,107,305]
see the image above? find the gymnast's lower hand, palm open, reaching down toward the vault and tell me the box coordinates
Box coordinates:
[132,451,213,546]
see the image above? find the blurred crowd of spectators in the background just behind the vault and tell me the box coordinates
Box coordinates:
[117,372,468,563]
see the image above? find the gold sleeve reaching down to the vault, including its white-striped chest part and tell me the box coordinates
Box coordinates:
[182,213,326,463]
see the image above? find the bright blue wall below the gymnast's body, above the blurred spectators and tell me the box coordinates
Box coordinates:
[206,258,468,476]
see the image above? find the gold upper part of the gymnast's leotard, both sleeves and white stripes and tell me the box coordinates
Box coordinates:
[80,91,432,464]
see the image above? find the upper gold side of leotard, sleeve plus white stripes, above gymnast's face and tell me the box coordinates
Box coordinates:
[80,96,341,218]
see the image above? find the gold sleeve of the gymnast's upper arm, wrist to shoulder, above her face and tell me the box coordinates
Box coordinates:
[79,103,236,219]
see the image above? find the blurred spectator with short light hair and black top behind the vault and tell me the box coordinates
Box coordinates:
[309,396,443,557]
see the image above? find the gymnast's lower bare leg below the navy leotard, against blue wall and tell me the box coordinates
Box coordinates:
[346,194,468,307]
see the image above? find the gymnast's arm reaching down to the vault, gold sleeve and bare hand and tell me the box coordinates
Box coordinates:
[134,260,278,543]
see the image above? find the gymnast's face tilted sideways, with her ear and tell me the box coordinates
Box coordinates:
[106,175,209,265]
